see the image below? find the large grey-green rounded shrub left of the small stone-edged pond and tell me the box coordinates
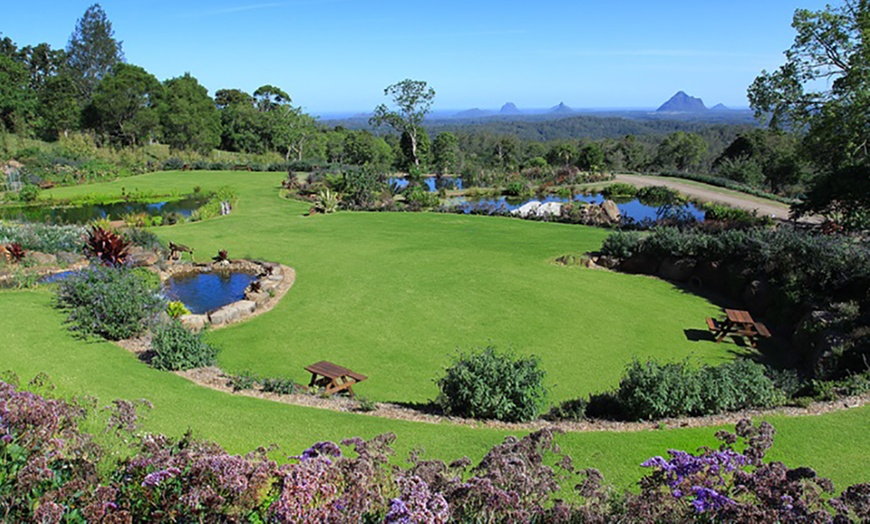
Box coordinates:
[56,266,166,340]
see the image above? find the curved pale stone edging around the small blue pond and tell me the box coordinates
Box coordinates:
[160,260,296,331]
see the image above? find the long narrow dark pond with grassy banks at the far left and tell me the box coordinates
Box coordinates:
[0,197,205,224]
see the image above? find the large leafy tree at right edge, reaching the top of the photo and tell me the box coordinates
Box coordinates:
[748,0,870,228]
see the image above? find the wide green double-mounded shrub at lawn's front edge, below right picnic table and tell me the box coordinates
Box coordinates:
[616,360,784,420]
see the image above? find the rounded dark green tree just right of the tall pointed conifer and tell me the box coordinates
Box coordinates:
[83,63,163,145]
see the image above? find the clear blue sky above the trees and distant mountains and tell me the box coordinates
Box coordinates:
[0,0,836,114]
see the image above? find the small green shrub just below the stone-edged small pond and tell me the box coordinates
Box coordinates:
[151,320,217,371]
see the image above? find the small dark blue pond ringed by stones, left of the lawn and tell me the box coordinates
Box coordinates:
[163,271,257,315]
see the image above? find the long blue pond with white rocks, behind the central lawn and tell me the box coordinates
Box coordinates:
[448,194,704,222]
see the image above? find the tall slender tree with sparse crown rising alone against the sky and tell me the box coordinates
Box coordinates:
[369,79,435,168]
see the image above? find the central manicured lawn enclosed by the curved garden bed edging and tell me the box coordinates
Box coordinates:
[49,173,731,402]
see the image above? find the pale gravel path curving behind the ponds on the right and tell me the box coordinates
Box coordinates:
[616,175,819,223]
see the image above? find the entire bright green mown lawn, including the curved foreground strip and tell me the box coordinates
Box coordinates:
[0,172,870,492]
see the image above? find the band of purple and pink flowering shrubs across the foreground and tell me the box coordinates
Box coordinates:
[0,376,870,523]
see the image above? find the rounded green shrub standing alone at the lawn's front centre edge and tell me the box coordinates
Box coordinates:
[437,346,546,422]
